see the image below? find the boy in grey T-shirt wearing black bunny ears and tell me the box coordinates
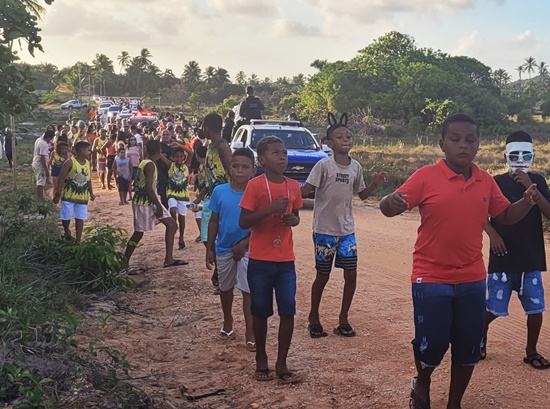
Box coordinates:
[302,114,386,338]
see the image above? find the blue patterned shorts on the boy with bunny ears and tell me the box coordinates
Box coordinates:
[313,233,357,275]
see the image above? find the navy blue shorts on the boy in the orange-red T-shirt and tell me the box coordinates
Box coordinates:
[247,259,296,318]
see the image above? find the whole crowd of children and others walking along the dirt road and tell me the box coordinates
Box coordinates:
[33,110,550,409]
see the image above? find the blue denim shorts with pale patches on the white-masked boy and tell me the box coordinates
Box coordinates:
[487,271,546,317]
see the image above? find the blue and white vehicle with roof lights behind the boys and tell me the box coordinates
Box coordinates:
[230,119,327,186]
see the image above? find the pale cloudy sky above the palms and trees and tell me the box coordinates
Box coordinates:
[16,0,550,79]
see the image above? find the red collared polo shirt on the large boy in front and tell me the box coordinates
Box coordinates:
[397,159,510,284]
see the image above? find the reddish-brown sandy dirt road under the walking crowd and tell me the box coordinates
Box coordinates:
[82,182,550,409]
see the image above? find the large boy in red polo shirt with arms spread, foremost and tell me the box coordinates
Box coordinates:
[380,114,541,409]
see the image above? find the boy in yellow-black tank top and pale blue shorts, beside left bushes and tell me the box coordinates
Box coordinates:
[53,141,95,243]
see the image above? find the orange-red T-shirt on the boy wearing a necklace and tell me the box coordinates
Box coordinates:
[240,175,302,262]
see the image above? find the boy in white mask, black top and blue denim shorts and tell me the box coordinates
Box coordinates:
[481,131,550,369]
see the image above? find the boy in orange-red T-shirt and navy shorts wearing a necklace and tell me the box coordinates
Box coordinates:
[239,136,302,383]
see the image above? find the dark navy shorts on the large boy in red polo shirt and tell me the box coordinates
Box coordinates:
[412,280,486,367]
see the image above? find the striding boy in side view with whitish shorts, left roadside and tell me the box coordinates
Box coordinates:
[125,140,188,267]
